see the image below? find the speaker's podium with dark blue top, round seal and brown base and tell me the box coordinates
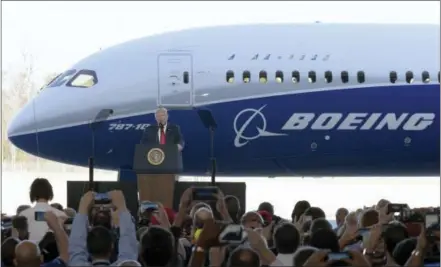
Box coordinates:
[133,143,183,207]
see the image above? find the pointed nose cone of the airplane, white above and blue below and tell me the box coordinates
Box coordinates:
[7,101,38,155]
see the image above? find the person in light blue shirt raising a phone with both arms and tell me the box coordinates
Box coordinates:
[69,190,138,266]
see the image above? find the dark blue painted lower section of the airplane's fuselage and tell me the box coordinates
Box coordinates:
[12,84,440,176]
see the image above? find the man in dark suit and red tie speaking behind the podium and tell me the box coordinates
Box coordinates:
[141,108,184,151]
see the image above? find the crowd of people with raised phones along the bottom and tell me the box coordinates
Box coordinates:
[1,178,440,267]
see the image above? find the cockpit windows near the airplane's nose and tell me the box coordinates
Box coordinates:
[46,70,98,88]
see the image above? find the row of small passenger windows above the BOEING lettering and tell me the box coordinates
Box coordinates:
[226,70,440,83]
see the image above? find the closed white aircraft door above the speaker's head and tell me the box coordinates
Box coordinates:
[158,54,193,108]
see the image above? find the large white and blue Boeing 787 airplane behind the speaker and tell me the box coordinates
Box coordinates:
[8,23,440,180]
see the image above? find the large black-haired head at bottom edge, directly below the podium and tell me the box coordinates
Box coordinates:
[139,226,175,267]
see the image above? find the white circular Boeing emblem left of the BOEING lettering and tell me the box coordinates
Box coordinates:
[233,105,287,147]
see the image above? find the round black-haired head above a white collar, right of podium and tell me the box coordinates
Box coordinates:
[273,223,300,254]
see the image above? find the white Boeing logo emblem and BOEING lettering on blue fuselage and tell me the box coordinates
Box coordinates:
[233,105,435,147]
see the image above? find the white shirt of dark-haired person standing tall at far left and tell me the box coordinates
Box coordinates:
[19,202,67,242]
